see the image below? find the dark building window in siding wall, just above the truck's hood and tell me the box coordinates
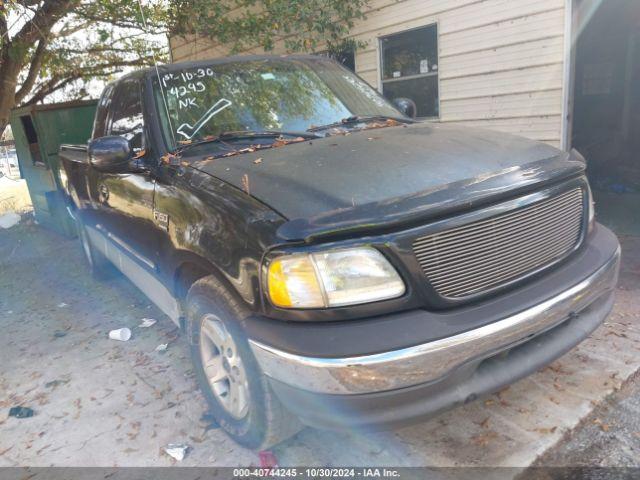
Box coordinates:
[380,24,440,117]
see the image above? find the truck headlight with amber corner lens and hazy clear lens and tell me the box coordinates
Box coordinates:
[267,247,405,308]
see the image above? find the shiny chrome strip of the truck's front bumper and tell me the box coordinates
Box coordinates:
[249,247,620,395]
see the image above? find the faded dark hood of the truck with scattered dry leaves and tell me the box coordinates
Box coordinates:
[187,123,584,241]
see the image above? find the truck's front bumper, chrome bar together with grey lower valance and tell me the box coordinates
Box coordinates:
[250,226,620,427]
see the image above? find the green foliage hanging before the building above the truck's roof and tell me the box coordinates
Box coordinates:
[169,0,369,53]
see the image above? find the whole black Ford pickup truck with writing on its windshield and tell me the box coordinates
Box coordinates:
[60,56,619,448]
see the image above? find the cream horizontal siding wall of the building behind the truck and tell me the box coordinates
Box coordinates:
[171,0,565,146]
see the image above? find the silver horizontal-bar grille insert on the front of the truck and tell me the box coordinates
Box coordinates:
[413,188,584,299]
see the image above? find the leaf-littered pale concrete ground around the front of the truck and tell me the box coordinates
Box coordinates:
[0,222,640,467]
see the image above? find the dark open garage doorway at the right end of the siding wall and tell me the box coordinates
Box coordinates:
[572,0,640,235]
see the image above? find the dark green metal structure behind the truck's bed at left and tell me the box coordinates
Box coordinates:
[10,100,97,236]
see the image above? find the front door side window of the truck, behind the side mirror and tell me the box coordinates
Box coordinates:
[108,80,144,152]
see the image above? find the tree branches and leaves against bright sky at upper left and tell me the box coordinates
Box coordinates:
[0,0,168,134]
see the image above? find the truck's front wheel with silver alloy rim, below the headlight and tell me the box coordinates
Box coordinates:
[186,276,301,449]
